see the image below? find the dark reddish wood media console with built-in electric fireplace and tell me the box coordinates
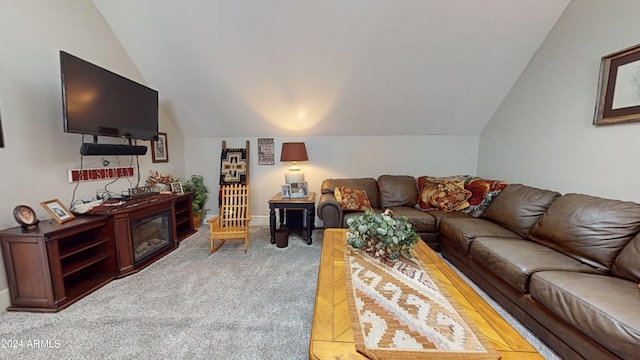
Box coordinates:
[0,194,195,312]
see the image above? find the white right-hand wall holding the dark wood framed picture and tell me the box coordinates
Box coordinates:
[478,0,640,202]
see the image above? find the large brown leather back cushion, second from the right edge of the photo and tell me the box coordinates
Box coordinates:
[529,194,640,272]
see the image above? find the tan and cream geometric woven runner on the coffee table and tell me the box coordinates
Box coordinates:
[345,246,500,360]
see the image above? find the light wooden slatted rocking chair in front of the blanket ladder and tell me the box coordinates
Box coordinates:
[209,184,251,253]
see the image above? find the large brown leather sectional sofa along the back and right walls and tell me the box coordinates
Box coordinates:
[317,175,640,359]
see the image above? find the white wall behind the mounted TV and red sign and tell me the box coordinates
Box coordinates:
[0,0,184,309]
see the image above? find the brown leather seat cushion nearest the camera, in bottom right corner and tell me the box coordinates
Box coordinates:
[529,271,640,359]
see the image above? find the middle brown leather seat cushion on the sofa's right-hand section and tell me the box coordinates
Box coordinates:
[469,237,597,294]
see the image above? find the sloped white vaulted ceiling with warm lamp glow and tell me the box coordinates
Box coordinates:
[93,0,570,137]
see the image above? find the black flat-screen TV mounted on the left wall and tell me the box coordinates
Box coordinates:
[60,51,158,140]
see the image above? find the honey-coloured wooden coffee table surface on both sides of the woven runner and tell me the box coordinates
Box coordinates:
[309,229,544,360]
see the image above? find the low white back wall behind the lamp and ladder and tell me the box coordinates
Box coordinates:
[185,134,479,225]
